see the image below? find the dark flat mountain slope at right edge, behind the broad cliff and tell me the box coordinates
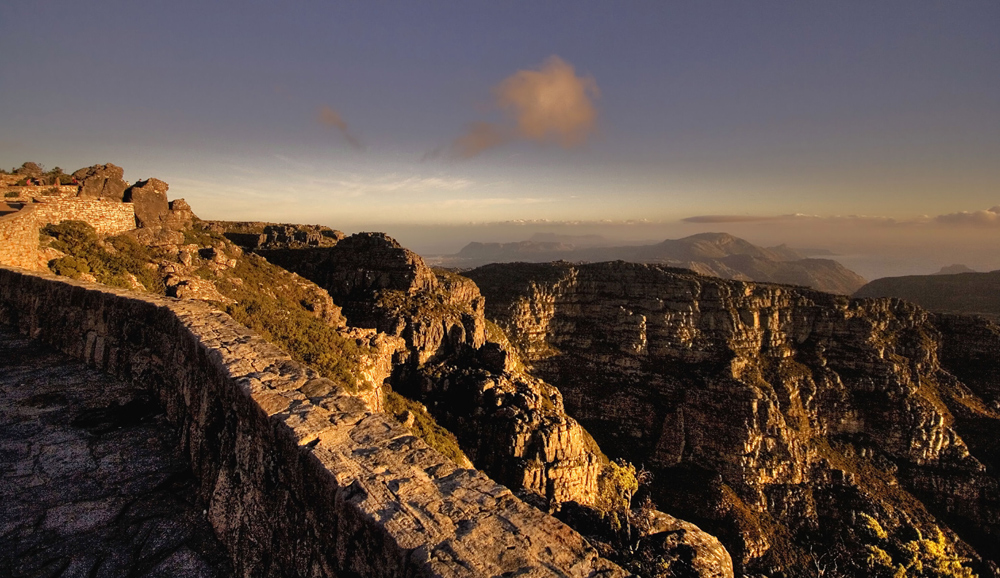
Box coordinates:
[854,267,1000,317]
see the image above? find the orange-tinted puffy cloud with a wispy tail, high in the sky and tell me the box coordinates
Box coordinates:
[434,56,600,159]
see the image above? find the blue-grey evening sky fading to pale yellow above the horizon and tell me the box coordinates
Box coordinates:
[0,0,1000,278]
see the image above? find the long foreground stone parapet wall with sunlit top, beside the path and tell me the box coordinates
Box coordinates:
[0,268,622,576]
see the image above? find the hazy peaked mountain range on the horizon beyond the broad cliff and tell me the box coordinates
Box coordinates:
[435,233,865,295]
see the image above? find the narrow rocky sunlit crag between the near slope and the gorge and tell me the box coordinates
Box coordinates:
[241,233,603,503]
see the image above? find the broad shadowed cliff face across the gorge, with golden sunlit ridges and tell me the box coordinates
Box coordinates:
[467,262,1000,576]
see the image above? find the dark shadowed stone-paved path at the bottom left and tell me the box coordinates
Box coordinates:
[0,325,231,578]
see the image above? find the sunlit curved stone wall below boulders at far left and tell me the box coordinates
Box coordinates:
[0,199,135,270]
